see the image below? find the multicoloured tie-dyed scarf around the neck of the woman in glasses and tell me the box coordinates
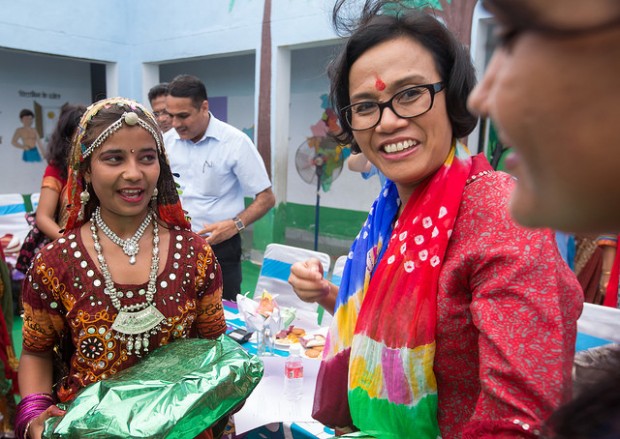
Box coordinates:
[313,142,471,439]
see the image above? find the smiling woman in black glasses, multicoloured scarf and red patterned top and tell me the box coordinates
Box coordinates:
[289,0,583,439]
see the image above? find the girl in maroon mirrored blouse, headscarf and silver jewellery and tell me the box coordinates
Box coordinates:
[16,98,226,439]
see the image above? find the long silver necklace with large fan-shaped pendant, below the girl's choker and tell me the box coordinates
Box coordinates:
[90,208,165,356]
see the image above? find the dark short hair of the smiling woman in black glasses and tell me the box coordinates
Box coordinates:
[328,0,477,149]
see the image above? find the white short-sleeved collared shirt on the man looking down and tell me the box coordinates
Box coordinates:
[164,113,271,232]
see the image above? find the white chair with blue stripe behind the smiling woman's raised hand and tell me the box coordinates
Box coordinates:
[254,244,331,323]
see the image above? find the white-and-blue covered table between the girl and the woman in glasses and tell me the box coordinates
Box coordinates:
[223,300,334,439]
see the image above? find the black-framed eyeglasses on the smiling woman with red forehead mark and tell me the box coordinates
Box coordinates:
[340,82,444,131]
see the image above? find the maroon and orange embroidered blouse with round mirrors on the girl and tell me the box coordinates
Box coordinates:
[23,228,226,401]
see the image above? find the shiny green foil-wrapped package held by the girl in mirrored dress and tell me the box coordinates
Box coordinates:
[43,335,263,439]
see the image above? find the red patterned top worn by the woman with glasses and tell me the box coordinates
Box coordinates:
[434,157,583,439]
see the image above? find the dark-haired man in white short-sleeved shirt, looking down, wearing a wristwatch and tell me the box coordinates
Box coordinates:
[164,75,275,300]
